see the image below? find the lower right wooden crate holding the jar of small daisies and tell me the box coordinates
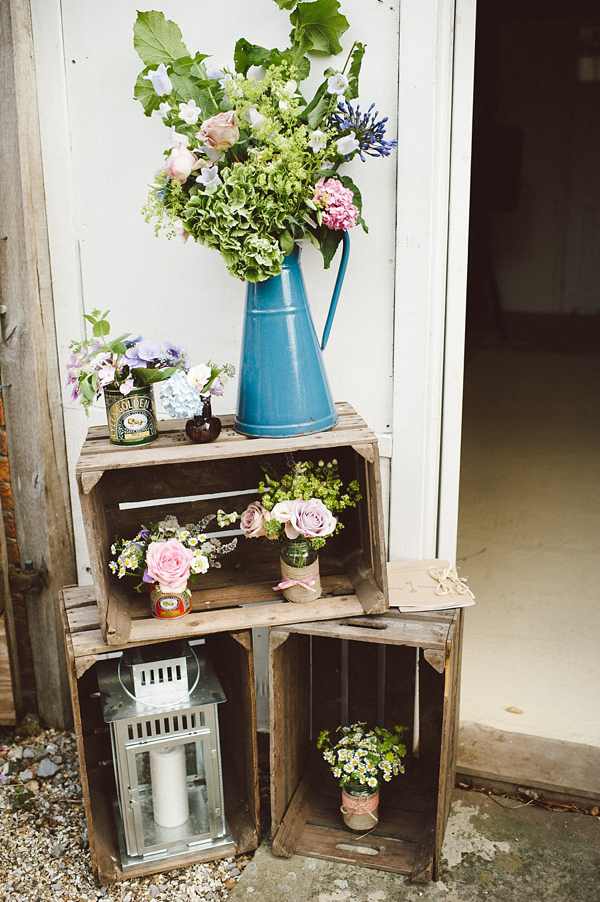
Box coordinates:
[269,611,462,883]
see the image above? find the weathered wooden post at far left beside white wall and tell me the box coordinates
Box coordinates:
[0,0,76,728]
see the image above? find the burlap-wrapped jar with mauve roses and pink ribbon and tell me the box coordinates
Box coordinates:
[217,459,361,603]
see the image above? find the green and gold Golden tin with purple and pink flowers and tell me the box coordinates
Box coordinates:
[67,309,188,447]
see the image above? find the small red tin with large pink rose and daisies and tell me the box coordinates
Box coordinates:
[108,514,237,619]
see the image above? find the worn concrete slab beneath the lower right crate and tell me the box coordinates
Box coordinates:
[228,790,600,902]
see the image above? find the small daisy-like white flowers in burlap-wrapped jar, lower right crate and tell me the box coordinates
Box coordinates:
[317,721,406,832]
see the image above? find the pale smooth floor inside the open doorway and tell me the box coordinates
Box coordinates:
[458,348,600,748]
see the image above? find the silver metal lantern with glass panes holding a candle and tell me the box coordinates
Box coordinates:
[97,640,233,869]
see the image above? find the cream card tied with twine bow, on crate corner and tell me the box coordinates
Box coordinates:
[388,558,475,613]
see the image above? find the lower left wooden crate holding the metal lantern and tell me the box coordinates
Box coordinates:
[61,587,260,885]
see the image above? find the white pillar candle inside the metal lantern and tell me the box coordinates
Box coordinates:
[150,745,190,827]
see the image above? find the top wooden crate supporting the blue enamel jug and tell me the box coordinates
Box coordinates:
[76,404,387,645]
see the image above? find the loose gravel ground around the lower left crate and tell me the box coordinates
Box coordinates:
[0,717,251,902]
